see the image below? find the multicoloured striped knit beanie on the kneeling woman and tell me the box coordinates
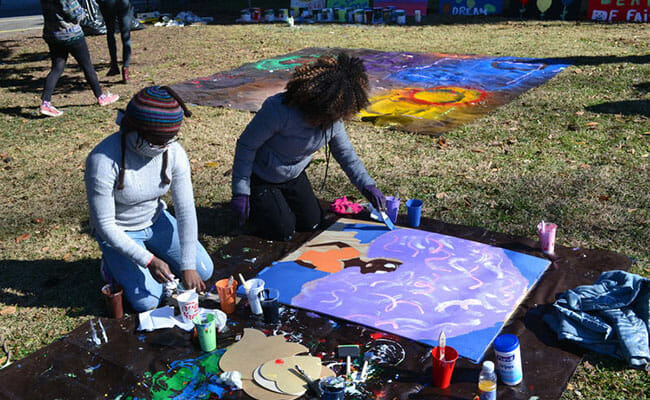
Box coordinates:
[124,86,191,138]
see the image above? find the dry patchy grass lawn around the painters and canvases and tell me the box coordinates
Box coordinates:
[0,20,650,400]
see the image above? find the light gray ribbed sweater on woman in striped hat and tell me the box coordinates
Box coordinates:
[85,132,198,270]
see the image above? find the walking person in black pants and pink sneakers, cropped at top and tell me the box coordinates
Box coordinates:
[40,0,120,117]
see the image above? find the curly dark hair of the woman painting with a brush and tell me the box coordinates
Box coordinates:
[284,53,369,129]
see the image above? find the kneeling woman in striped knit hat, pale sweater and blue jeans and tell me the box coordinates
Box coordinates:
[85,86,213,312]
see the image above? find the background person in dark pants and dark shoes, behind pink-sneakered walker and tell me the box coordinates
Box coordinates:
[98,0,133,83]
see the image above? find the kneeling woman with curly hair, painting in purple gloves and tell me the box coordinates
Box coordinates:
[231,53,386,240]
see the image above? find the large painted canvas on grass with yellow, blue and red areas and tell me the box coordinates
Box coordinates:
[168,48,567,135]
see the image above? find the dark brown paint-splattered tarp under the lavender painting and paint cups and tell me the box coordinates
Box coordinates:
[0,211,632,400]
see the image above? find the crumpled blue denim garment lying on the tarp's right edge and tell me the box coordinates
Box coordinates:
[544,271,650,368]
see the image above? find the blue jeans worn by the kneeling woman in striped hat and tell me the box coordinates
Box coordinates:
[95,210,214,312]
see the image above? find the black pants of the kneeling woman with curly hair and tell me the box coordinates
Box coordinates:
[250,171,323,240]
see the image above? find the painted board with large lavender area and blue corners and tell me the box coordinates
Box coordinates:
[253,219,550,362]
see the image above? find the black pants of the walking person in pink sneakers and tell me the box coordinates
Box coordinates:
[41,37,102,101]
